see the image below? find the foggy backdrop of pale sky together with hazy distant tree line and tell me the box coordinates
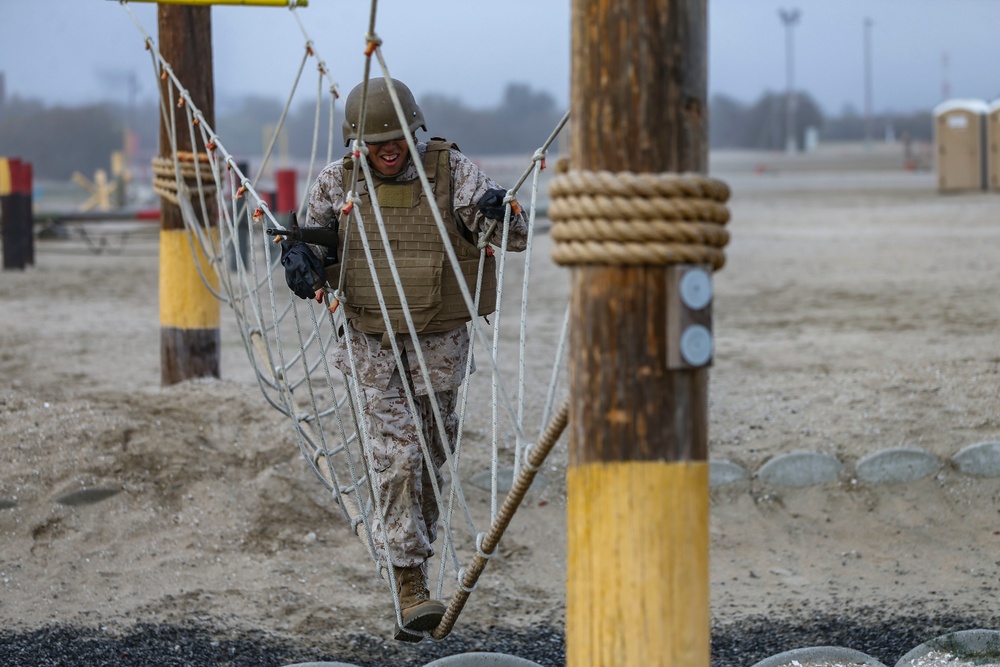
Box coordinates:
[0,0,1000,178]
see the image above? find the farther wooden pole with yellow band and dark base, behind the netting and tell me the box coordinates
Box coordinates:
[157,5,220,386]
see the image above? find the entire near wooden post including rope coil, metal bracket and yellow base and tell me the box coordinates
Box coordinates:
[550,0,728,667]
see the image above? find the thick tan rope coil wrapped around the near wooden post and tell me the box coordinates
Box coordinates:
[549,171,729,270]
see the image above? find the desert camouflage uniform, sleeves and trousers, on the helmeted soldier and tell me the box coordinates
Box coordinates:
[306,142,528,567]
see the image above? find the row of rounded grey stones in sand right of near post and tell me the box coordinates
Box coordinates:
[709,442,1000,488]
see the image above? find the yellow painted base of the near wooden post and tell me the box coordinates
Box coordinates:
[566,461,710,667]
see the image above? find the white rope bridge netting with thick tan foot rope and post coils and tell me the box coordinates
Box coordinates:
[120,0,729,639]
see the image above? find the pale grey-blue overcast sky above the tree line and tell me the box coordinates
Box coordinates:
[0,0,1000,114]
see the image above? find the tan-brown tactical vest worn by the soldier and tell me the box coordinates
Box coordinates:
[344,141,497,334]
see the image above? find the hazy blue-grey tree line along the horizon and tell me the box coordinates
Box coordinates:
[0,83,933,180]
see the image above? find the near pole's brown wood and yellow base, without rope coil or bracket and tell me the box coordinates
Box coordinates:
[566,0,710,667]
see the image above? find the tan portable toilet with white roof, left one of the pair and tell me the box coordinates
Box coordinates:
[934,100,989,192]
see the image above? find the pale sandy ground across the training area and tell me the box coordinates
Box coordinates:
[0,147,1000,664]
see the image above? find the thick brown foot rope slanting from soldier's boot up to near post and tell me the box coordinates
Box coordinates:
[431,400,569,639]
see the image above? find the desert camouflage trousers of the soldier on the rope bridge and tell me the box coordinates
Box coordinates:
[365,370,458,567]
